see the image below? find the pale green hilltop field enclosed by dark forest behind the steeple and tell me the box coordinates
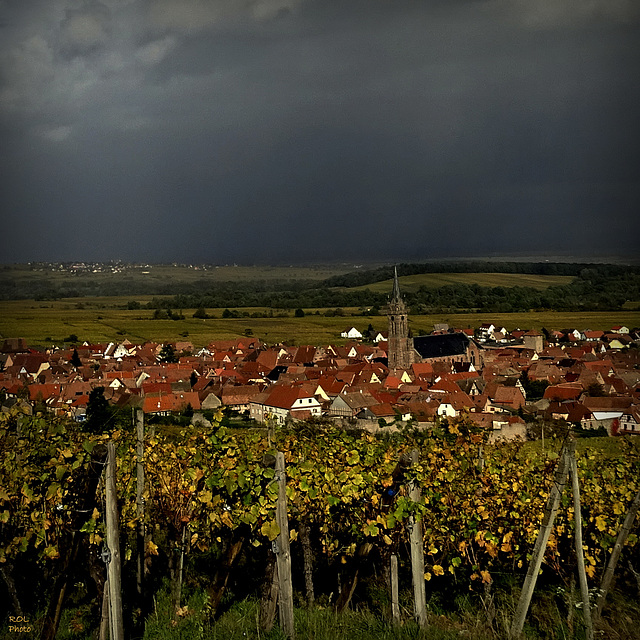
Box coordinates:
[349,273,574,293]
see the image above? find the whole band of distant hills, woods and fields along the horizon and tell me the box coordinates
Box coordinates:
[0,261,640,315]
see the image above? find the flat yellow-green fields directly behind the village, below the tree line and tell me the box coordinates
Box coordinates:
[0,296,640,346]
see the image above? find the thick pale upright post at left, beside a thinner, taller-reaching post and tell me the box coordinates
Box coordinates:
[105,441,124,640]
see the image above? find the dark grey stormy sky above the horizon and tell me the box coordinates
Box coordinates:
[0,0,640,263]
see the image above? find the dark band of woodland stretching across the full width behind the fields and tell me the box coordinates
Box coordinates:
[0,261,640,314]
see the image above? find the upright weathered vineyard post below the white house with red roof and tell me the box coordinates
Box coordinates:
[276,451,295,638]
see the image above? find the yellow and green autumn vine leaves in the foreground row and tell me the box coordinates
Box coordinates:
[0,415,640,620]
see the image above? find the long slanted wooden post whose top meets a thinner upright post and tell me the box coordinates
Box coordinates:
[509,447,569,638]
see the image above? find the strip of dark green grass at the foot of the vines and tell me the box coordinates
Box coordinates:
[127,580,639,640]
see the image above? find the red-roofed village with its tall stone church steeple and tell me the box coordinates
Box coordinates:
[0,275,640,440]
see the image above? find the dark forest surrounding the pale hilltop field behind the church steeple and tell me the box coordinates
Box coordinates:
[148,263,640,314]
